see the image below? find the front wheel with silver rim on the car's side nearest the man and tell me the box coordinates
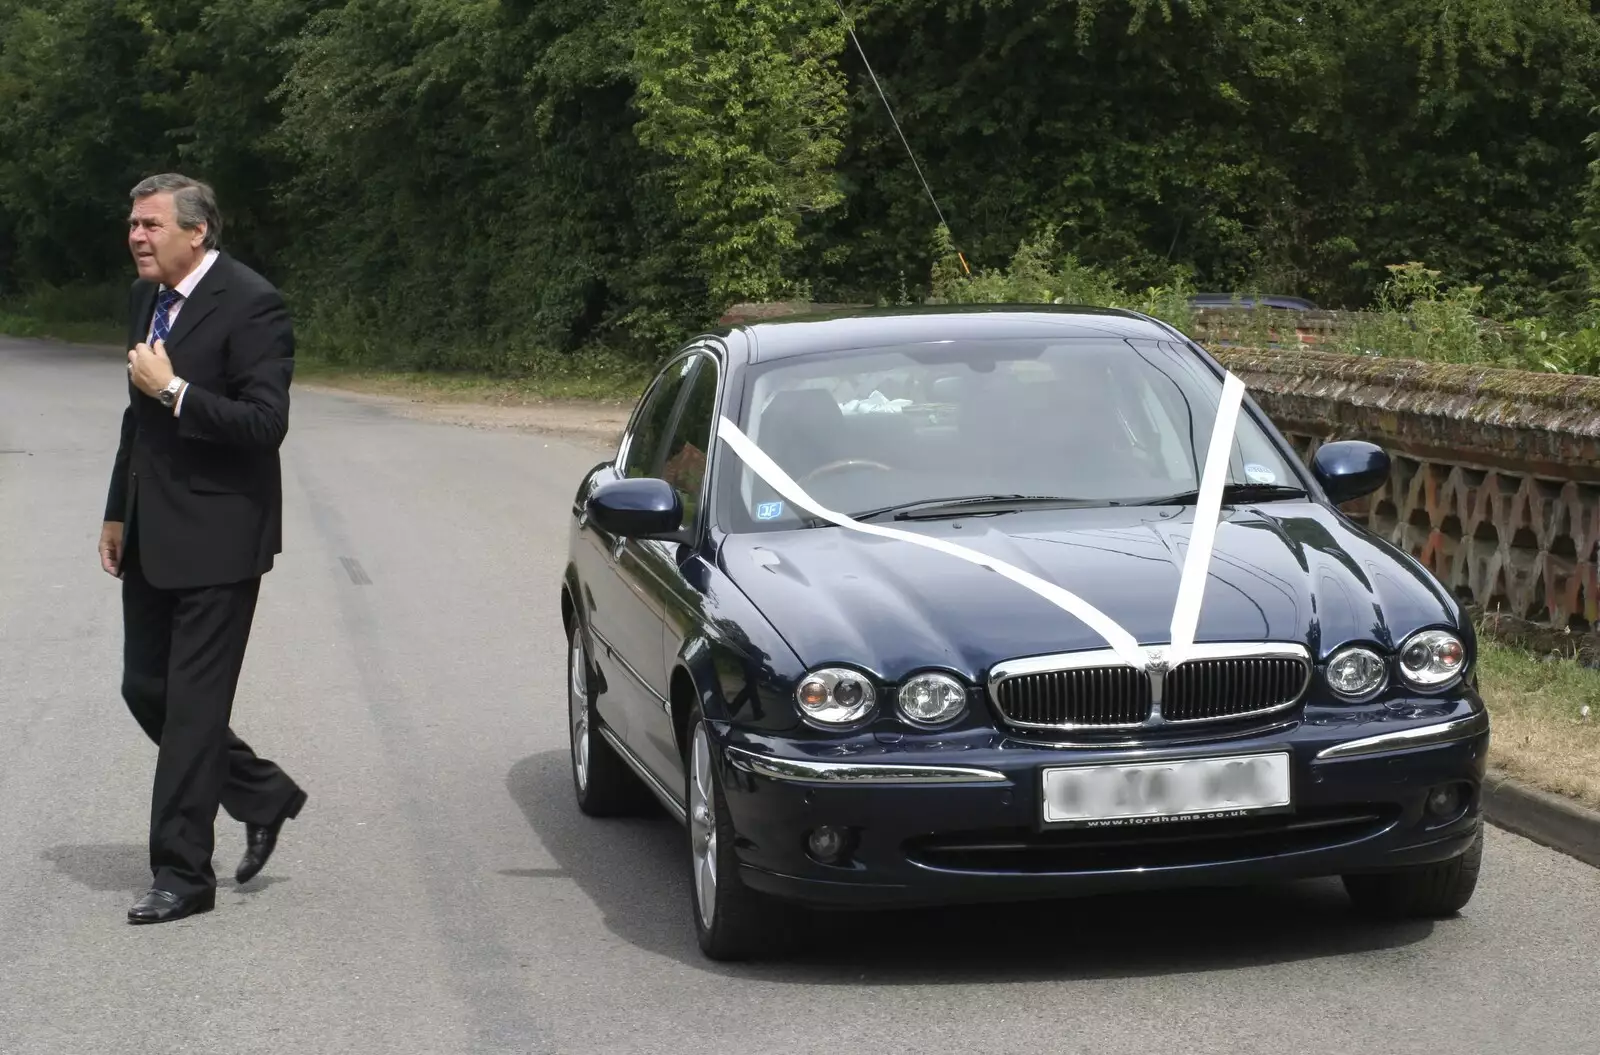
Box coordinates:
[683,703,790,961]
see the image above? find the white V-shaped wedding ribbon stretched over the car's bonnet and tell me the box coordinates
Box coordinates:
[717,373,1245,669]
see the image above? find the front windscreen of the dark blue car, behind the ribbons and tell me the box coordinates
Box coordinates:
[722,338,1302,532]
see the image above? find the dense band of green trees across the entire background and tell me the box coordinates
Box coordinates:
[0,0,1600,371]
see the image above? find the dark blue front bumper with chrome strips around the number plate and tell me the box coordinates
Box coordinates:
[715,700,1490,908]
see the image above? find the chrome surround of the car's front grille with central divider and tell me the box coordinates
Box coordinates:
[986,642,1314,732]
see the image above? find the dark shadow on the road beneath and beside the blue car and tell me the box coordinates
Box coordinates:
[506,751,1434,985]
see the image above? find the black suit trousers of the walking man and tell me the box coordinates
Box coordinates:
[122,537,304,897]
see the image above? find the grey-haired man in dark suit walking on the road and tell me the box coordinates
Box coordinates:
[99,174,306,924]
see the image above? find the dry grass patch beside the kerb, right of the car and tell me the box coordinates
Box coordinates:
[1478,642,1600,808]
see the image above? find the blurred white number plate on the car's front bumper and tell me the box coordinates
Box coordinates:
[1043,751,1293,828]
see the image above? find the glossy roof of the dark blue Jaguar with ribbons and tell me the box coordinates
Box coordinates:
[728,304,1174,362]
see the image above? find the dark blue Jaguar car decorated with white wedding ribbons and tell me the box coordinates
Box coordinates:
[560,307,1490,959]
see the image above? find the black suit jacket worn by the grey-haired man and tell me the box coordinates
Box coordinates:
[106,253,294,589]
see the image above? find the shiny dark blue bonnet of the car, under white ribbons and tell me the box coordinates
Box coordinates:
[720,501,1454,680]
